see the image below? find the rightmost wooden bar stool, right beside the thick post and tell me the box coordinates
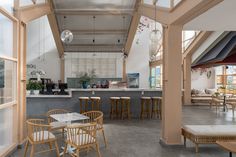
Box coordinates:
[151,97,162,119]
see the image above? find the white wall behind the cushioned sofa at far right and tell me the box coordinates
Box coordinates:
[191,68,215,90]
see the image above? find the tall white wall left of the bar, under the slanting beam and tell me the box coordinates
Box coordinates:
[27,16,60,82]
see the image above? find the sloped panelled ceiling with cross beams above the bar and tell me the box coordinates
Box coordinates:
[53,0,136,52]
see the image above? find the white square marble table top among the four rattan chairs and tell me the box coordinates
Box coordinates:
[51,112,89,122]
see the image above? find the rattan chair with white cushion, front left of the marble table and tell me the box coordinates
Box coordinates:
[24,119,60,157]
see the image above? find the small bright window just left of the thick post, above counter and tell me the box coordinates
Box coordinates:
[150,65,162,88]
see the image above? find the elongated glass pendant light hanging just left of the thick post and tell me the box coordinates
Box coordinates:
[149,0,162,60]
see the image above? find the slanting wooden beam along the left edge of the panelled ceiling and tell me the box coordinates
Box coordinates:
[47,1,64,57]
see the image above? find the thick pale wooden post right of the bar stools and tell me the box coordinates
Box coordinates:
[161,25,182,145]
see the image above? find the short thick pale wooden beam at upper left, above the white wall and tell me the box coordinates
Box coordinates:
[16,3,52,23]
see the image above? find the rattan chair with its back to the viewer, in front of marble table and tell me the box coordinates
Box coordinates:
[63,123,101,157]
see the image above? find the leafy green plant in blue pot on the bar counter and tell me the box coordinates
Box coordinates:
[79,70,96,89]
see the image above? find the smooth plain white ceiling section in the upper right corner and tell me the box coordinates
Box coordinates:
[184,0,236,31]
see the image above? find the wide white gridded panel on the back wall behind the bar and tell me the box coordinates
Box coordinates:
[65,53,123,78]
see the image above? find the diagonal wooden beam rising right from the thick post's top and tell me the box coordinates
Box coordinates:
[170,0,223,25]
